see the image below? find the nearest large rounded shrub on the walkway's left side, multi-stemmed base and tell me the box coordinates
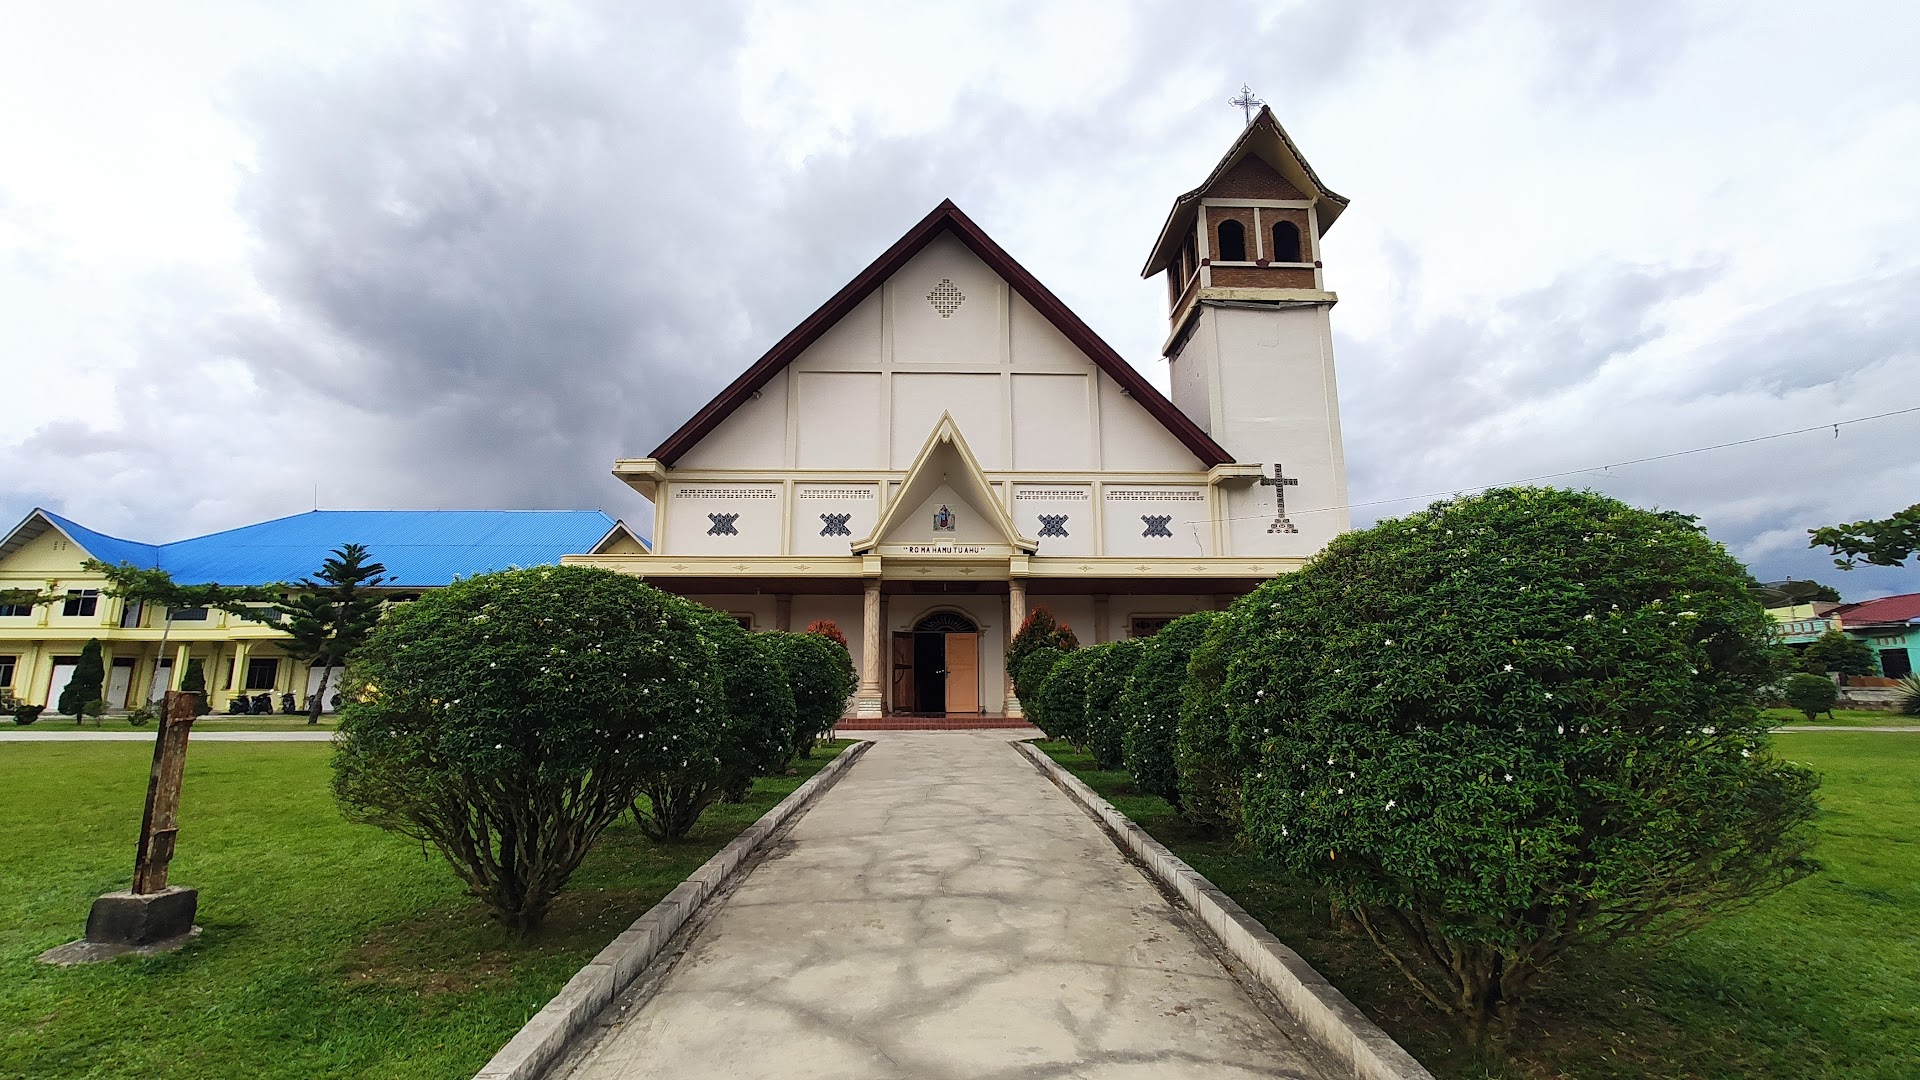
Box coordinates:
[332,567,726,934]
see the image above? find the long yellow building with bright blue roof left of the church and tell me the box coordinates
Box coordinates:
[0,509,647,711]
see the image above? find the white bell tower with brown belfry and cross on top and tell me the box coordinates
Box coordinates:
[1140,106,1350,557]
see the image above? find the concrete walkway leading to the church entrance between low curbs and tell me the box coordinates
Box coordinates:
[564,732,1336,1080]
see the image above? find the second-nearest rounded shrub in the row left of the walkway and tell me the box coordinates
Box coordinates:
[634,607,793,826]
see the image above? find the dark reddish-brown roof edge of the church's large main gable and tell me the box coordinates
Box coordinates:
[653,198,1233,467]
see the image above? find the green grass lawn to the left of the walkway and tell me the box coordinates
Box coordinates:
[0,724,847,1080]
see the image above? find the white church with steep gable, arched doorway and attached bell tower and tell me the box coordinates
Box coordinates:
[566,110,1348,719]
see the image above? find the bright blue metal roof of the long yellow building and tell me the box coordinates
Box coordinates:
[40,509,633,588]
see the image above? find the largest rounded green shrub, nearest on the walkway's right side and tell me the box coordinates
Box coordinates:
[1228,488,1816,1038]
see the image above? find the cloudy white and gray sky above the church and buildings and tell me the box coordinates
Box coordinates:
[0,0,1920,596]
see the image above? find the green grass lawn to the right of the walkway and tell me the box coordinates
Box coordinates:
[1041,732,1920,1080]
